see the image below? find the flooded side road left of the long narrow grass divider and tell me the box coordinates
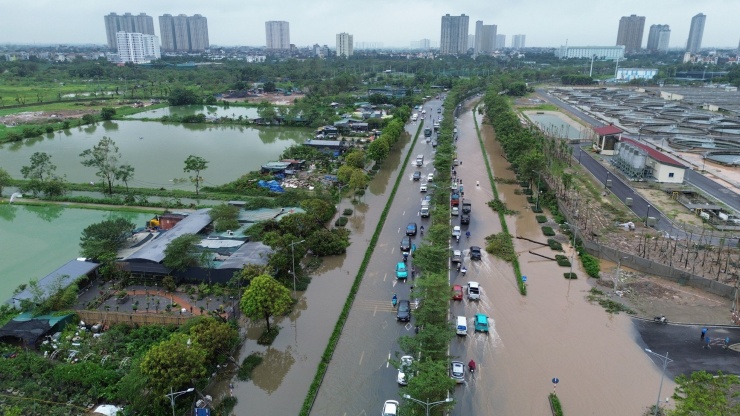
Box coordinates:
[228,122,416,415]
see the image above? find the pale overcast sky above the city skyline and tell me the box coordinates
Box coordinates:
[0,0,740,48]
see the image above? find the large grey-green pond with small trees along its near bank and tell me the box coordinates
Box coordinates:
[0,120,313,189]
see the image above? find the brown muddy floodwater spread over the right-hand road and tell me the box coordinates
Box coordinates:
[468,109,675,416]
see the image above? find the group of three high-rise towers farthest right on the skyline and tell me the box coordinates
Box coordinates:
[617,13,707,53]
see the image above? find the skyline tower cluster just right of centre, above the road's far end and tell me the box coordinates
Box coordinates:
[439,14,526,56]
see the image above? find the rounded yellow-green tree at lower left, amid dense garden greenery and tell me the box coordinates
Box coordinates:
[141,334,207,396]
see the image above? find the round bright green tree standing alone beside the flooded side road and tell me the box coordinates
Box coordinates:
[239,274,293,331]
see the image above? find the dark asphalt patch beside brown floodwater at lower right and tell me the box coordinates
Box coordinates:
[632,317,740,377]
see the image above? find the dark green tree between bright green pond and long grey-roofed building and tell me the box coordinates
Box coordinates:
[80,218,136,259]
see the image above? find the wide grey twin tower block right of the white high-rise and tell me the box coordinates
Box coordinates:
[159,14,210,52]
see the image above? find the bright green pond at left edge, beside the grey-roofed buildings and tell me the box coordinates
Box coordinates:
[0,203,152,302]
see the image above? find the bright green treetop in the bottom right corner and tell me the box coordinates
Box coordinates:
[669,370,740,416]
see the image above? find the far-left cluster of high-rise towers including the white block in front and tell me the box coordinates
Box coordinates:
[104,13,209,63]
